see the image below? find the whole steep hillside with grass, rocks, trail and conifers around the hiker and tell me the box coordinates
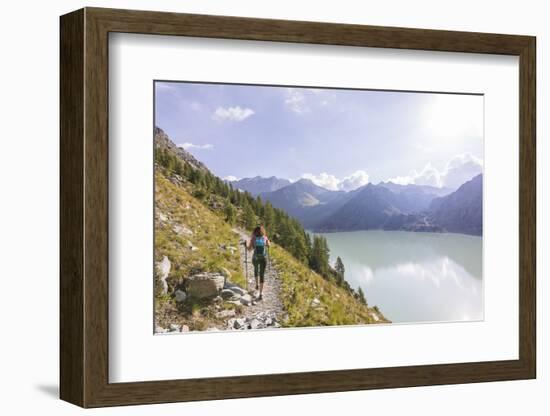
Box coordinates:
[155,129,388,332]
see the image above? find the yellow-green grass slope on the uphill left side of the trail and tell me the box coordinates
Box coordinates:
[155,169,245,330]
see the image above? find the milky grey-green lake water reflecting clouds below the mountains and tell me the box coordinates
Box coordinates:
[317,230,483,323]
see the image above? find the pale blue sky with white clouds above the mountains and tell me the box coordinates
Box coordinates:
[155,82,483,190]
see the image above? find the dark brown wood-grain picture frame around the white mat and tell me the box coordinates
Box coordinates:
[60,8,536,407]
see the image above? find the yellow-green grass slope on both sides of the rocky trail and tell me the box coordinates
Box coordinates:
[155,169,387,330]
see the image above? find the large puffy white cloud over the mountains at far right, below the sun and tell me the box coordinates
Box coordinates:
[389,153,483,189]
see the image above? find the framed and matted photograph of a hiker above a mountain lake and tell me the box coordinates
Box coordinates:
[60,8,536,407]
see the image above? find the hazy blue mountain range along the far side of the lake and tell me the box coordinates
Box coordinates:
[232,174,483,235]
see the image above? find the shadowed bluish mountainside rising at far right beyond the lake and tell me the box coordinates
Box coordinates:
[429,174,483,235]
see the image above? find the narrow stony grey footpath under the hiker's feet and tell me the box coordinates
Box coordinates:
[222,230,285,330]
